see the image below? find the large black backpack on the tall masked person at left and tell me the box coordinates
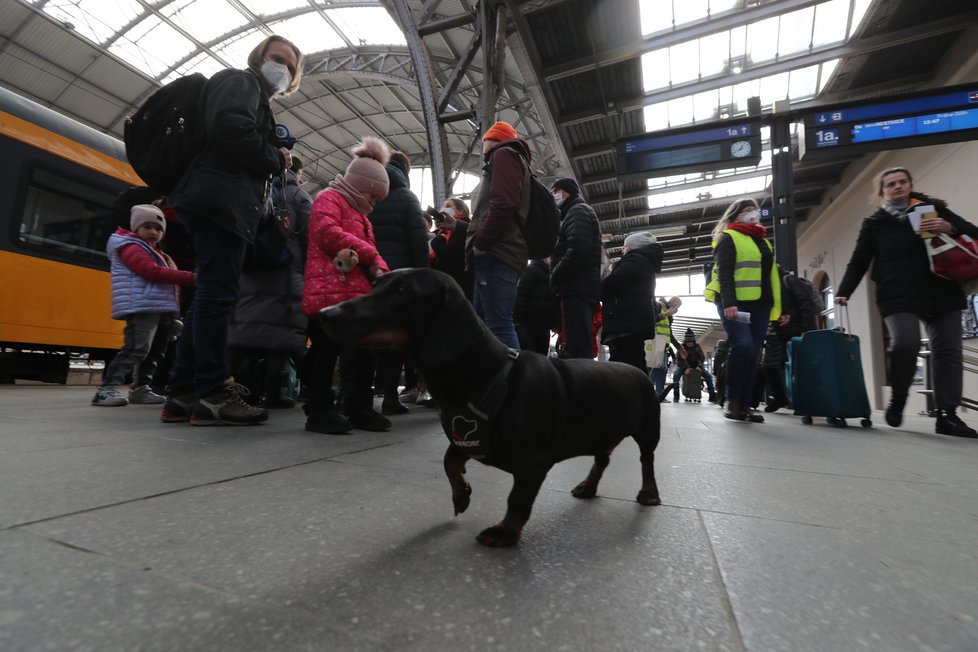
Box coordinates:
[123,72,207,195]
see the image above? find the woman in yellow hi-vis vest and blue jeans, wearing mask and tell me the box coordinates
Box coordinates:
[703,198,781,423]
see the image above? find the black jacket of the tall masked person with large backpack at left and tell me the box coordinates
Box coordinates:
[168,68,285,242]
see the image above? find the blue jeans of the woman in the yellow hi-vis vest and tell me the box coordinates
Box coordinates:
[717,302,771,410]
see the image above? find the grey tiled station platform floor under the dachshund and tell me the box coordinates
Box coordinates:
[0,386,978,652]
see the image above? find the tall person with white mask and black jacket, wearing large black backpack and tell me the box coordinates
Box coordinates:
[160,35,302,425]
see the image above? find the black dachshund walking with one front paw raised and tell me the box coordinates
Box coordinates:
[320,269,661,547]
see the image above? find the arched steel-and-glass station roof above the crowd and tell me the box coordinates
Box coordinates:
[0,0,978,288]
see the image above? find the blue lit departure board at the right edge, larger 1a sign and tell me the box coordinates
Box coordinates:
[803,83,978,156]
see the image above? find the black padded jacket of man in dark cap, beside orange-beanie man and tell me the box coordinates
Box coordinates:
[550,195,601,301]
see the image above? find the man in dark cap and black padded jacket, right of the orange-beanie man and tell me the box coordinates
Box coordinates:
[550,179,601,359]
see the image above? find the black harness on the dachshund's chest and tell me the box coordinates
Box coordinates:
[441,349,520,460]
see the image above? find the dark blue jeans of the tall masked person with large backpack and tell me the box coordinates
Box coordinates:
[168,215,247,398]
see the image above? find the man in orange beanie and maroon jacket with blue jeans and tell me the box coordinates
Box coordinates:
[465,122,530,350]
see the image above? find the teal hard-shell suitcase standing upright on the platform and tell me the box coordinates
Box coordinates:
[785,330,873,428]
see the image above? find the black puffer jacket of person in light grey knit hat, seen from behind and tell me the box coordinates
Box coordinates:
[601,243,663,343]
